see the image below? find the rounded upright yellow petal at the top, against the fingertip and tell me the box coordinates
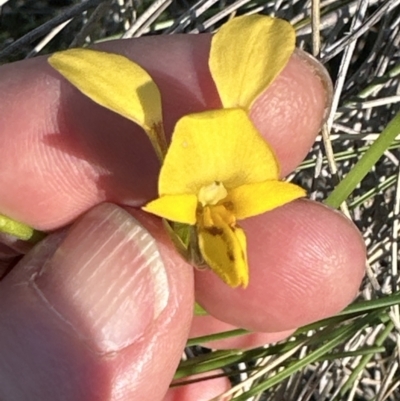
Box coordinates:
[209,15,295,109]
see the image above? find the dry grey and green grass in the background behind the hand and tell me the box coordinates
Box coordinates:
[0,0,400,401]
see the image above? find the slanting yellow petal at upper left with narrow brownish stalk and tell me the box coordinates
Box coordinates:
[49,49,166,160]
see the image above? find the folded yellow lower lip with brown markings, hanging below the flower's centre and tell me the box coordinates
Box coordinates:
[198,208,249,288]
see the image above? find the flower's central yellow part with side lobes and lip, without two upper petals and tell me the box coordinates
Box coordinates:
[143,109,305,287]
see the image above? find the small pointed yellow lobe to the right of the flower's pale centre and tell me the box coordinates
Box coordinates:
[228,180,306,219]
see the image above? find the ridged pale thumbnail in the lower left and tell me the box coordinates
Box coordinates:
[33,204,169,354]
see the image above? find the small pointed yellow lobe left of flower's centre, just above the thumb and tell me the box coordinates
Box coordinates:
[142,194,197,225]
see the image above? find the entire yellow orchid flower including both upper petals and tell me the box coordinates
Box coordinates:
[49,15,305,287]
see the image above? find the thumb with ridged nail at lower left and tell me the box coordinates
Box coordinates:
[0,204,193,401]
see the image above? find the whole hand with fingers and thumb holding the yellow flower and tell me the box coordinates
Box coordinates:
[0,35,365,401]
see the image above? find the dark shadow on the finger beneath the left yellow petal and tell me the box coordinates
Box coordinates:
[62,77,159,205]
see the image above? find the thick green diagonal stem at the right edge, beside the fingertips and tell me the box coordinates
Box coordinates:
[325,113,400,208]
